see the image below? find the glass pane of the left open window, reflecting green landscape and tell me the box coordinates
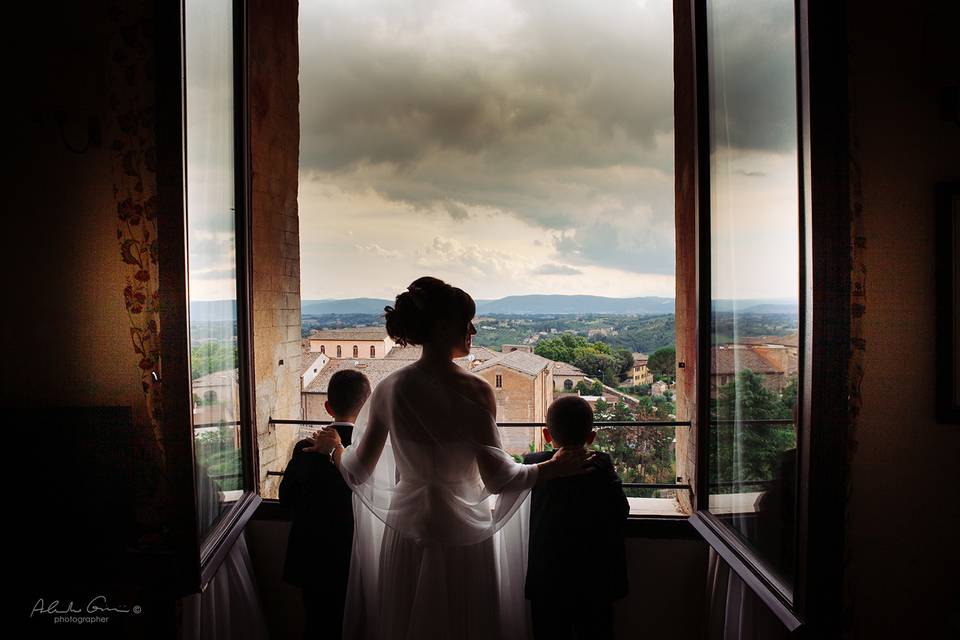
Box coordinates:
[185,0,243,538]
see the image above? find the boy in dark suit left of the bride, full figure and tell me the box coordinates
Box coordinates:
[280,369,370,639]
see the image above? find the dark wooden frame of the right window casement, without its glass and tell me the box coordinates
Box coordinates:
[674,0,850,637]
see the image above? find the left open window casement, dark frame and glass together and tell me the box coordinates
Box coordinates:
[157,0,260,592]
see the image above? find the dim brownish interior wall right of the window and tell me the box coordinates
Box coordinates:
[846,0,960,638]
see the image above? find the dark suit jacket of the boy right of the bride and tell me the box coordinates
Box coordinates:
[523,451,630,602]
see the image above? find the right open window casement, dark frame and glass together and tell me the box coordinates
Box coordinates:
[676,0,849,631]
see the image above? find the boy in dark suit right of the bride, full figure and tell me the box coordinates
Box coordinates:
[524,396,630,640]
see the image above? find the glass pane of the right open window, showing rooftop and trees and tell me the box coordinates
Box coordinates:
[707,0,800,584]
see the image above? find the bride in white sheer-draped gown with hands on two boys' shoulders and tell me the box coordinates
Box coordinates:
[313,277,587,640]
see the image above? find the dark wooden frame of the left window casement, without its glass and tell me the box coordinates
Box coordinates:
[155,0,261,594]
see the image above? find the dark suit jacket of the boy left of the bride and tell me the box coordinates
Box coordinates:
[280,425,353,590]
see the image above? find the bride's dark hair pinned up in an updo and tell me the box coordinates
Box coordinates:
[383,276,477,346]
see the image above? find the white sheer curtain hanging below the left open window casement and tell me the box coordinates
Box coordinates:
[180,532,268,640]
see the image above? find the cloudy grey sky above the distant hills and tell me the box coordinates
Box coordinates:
[299,0,796,299]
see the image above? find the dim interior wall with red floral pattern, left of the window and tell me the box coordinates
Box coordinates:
[0,1,163,524]
